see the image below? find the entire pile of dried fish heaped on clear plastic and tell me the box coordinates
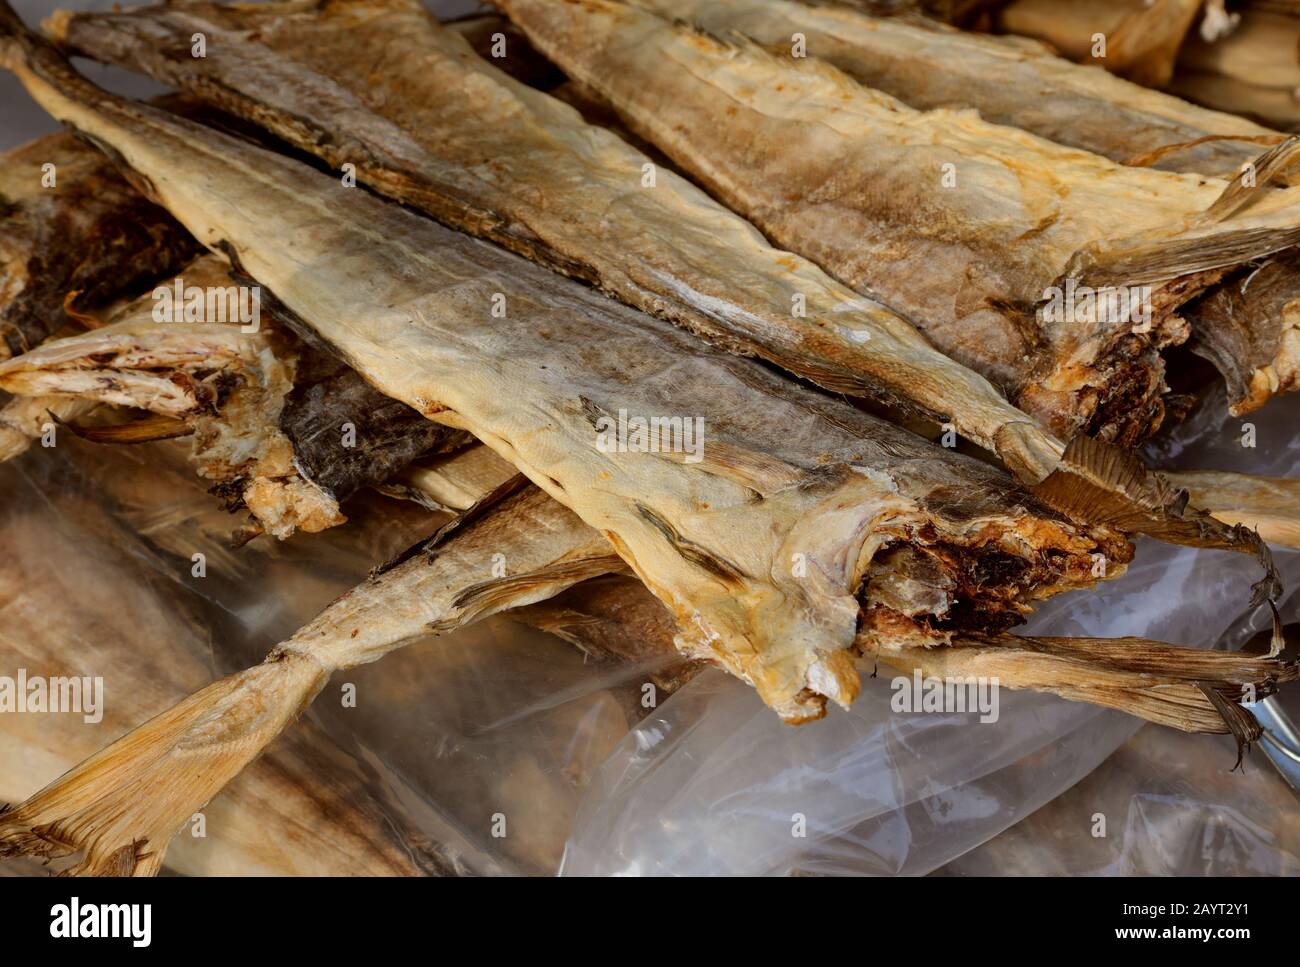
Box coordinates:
[0,0,1300,875]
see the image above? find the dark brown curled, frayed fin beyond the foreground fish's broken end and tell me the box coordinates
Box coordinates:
[1031,437,1282,607]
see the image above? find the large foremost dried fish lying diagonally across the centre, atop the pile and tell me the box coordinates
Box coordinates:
[0,7,1131,721]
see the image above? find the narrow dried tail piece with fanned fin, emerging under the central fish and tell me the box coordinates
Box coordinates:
[0,487,620,876]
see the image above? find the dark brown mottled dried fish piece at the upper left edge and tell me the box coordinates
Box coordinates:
[0,126,198,360]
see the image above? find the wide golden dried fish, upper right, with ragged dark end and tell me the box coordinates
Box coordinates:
[502,0,1300,445]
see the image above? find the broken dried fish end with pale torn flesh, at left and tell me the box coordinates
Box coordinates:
[0,255,469,539]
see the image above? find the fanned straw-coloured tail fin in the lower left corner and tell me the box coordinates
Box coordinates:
[0,650,329,876]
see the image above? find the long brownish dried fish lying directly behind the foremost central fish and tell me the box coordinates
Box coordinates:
[48,0,1062,481]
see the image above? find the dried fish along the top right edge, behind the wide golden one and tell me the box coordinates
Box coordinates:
[633,0,1284,178]
